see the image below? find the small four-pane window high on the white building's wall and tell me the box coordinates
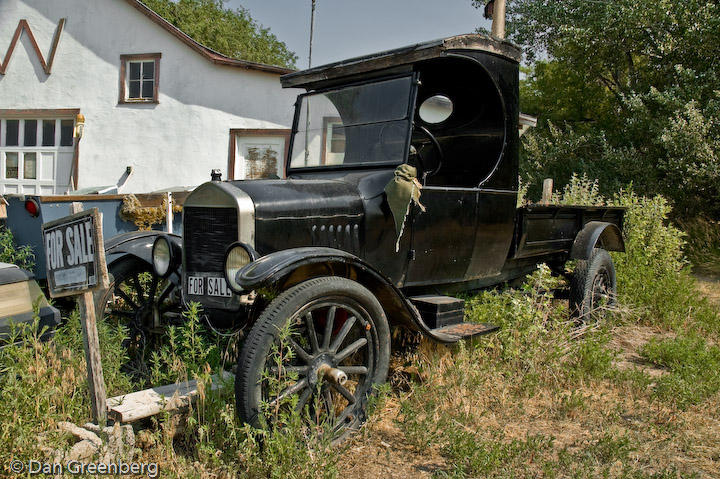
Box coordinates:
[118,53,161,103]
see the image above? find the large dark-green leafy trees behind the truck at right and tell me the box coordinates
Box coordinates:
[475,0,720,218]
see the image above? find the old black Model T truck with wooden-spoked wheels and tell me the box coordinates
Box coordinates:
[94,35,624,433]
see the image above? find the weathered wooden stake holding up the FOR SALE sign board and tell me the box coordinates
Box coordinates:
[70,203,107,427]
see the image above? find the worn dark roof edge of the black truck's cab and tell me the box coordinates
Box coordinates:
[280,33,522,89]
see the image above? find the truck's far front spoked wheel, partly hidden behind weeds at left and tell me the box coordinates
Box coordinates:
[95,257,180,380]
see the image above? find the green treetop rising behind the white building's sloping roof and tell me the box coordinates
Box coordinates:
[143,0,297,68]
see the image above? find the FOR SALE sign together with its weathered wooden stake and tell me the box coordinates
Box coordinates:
[42,203,108,425]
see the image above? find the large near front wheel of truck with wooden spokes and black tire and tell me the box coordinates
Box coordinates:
[236,277,390,441]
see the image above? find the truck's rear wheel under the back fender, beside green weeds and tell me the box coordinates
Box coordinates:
[570,248,617,323]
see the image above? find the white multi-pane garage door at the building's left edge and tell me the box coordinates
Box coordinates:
[0,117,75,195]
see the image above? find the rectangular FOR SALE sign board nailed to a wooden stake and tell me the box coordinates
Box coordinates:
[42,208,108,298]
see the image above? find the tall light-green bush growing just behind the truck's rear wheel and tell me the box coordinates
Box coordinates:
[553,173,720,334]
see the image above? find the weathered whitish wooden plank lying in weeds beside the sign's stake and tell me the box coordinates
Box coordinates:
[108,371,234,423]
